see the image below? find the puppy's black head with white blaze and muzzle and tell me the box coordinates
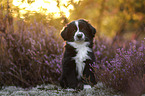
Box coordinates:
[61,19,96,42]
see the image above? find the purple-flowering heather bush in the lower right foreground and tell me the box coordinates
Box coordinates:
[94,42,145,92]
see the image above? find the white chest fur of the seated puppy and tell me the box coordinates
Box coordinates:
[68,42,92,79]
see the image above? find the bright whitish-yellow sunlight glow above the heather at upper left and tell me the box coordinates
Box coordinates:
[13,0,80,18]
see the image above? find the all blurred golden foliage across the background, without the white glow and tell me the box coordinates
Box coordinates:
[0,0,145,41]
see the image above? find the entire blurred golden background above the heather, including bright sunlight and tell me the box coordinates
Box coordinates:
[0,0,145,39]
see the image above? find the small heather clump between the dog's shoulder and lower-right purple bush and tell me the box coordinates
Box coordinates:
[93,37,118,65]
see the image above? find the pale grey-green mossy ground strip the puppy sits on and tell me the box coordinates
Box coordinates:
[0,83,124,96]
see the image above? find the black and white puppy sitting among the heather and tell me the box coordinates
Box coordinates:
[60,19,97,89]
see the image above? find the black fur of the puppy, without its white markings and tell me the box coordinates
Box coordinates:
[60,19,97,89]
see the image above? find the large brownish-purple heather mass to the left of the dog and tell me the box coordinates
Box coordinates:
[0,21,62,87]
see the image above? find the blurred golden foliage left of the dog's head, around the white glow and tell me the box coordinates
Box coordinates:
[0,0,71,31]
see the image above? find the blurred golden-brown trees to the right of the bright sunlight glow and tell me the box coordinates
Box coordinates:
[70,0,145,39]
